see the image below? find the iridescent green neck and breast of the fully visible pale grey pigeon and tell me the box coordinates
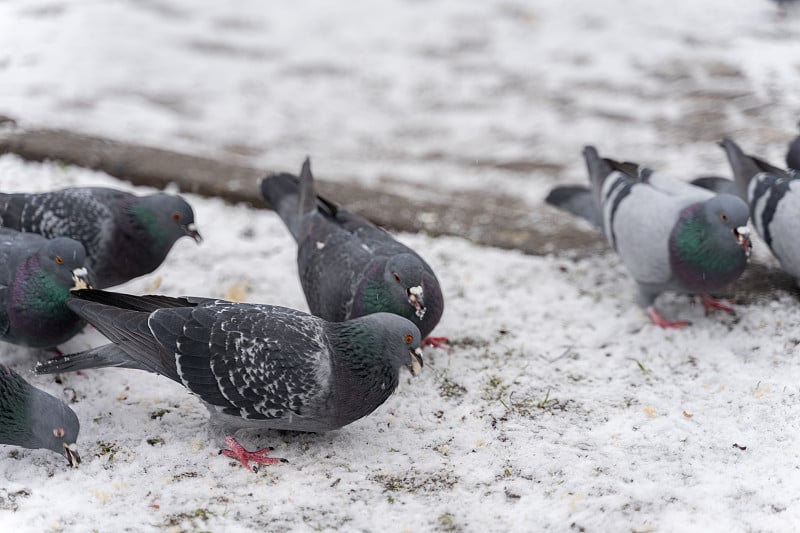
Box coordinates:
[669,204,747,292]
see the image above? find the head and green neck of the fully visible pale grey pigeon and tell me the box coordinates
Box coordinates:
[669,194,752,292]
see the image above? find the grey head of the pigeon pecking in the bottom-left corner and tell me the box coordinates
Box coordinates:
[26,387,81,467]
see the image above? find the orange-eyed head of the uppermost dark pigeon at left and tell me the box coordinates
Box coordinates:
[130,193,202,249]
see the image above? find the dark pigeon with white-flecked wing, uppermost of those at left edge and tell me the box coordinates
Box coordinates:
[0,187,201,289]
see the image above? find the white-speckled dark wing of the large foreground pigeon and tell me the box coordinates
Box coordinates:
[151,301,329,419]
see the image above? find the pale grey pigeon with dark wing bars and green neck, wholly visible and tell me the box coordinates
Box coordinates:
[546,146,751,328]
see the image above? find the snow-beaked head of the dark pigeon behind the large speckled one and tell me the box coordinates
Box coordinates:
[383,253,434,320]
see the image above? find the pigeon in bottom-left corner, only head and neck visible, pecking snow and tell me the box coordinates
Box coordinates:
[0,364,81,467]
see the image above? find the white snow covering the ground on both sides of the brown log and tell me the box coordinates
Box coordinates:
[0,0,800,532]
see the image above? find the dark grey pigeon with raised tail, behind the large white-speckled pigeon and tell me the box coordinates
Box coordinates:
[261,158,447,346]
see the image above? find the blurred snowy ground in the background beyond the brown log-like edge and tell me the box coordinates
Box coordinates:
[0,0,800,206]
